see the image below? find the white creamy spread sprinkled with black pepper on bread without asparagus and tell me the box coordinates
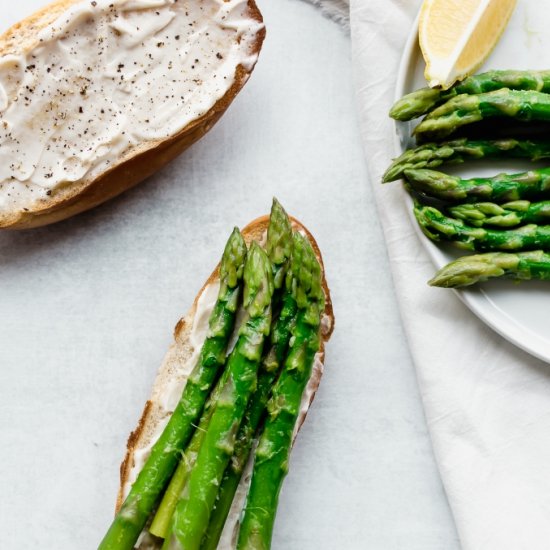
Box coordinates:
[0,0,263,213]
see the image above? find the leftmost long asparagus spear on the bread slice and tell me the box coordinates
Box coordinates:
[99,229,246,550]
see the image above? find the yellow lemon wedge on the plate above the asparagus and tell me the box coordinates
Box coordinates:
[418,0,516,89]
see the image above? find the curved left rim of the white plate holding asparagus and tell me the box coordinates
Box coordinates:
[393,11,550,363]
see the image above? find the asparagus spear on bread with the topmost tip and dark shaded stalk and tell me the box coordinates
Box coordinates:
[201,200,298,550]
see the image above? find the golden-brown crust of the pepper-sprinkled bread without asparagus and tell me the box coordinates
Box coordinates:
[0,0,265,229]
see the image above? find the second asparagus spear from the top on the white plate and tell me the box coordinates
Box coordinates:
[414,88,550,141]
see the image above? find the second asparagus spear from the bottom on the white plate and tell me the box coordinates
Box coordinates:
[414,204,550,252]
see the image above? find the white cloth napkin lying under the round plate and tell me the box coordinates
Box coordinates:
[351,0,550,550]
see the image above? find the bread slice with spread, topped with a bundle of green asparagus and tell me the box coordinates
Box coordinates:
[99,201,334,550]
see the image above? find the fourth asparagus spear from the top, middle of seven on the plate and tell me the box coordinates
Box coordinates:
[405,168,550,202]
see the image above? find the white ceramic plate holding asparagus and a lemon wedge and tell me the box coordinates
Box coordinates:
[395,0,550,363]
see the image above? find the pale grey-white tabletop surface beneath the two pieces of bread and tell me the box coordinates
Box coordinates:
[0,0,459,550]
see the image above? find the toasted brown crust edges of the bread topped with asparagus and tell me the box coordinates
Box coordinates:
[116,216,334,511]
